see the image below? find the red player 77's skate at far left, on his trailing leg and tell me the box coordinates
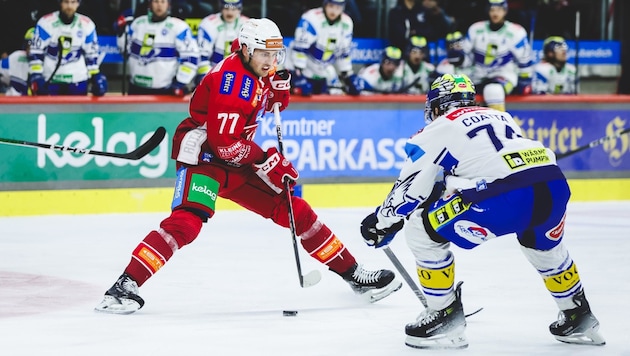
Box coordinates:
[94,273,144,314]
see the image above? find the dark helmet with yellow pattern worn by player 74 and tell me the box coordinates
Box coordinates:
[424,74,477,124]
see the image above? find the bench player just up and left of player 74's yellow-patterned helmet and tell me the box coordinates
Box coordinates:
[400,36,435,94]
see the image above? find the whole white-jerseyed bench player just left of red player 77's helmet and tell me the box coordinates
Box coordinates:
[196,0,249,83]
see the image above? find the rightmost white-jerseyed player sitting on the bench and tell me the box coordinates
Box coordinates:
[532,36,578,94]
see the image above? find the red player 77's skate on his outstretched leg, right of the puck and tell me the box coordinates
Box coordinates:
[341,264,402,303]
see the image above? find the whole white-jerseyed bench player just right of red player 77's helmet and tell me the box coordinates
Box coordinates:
[290,0,361,95]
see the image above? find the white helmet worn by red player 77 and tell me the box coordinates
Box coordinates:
[238,18,286,64]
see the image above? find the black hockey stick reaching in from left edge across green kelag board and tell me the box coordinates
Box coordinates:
[0,126,166,160]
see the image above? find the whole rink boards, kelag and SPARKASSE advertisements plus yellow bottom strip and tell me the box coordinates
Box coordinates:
[0,96,630,216]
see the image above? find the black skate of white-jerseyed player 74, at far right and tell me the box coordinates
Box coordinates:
[549,290,606,346]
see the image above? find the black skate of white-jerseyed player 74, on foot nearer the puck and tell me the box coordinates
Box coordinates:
[405,282,468,349]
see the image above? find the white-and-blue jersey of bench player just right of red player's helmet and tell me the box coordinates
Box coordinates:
[291,7,354,81]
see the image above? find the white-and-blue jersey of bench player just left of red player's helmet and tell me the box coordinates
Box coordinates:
[197,12,249,75]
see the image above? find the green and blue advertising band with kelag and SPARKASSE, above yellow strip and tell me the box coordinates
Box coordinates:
[0,96,630,190]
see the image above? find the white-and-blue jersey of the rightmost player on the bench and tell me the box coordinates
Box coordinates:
[532,62,577,94]
